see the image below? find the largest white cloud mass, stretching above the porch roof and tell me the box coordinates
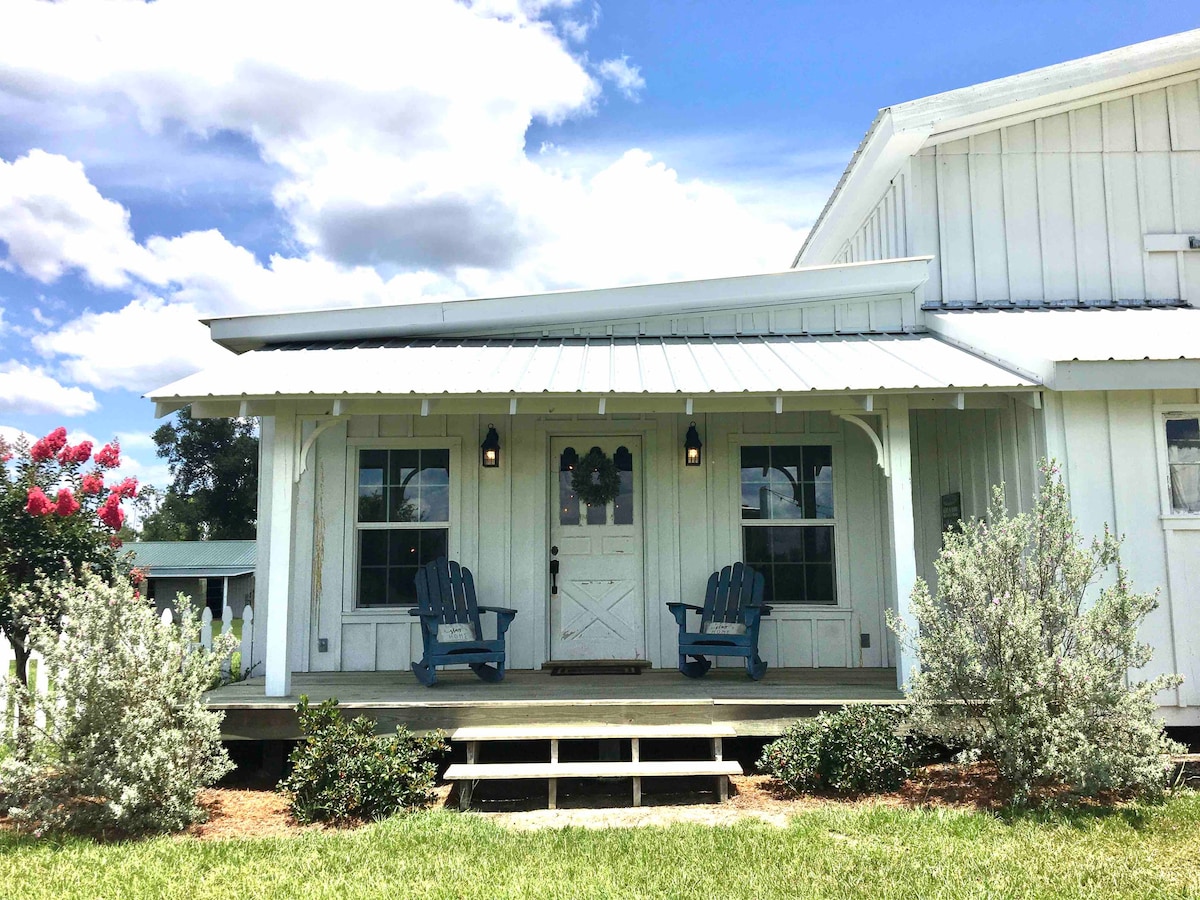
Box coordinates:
[0,0,820,391]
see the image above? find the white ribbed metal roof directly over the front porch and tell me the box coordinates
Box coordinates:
[149,334,1037,402]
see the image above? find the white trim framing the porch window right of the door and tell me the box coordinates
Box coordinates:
[730,432,853,613]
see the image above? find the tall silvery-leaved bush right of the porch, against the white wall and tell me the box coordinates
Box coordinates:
[889,463,1182,803]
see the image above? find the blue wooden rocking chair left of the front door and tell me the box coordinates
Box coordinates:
[408,557,517,688]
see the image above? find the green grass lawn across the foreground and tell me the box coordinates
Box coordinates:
[7,792,1200,900]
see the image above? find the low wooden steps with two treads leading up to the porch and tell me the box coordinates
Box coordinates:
[445,725,742,810]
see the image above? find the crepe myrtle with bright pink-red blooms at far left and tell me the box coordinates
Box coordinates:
[0,428,138,683]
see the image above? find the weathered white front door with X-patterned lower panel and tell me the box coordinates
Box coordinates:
[550,434,646,659]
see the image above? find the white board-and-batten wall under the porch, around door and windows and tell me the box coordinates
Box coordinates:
[278,412,893,672]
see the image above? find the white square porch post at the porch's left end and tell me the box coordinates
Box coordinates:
[264,410,296,697]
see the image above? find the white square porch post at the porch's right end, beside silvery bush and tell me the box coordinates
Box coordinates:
[888,397,918,689]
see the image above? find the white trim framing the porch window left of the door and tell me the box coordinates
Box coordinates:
[342,437,463,622]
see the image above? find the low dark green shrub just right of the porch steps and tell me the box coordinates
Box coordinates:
[758,706,916,793]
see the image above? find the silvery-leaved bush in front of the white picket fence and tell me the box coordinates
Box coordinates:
[0,574,235,835]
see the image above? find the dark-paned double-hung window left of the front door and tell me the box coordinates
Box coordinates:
[355,448,451,608]
